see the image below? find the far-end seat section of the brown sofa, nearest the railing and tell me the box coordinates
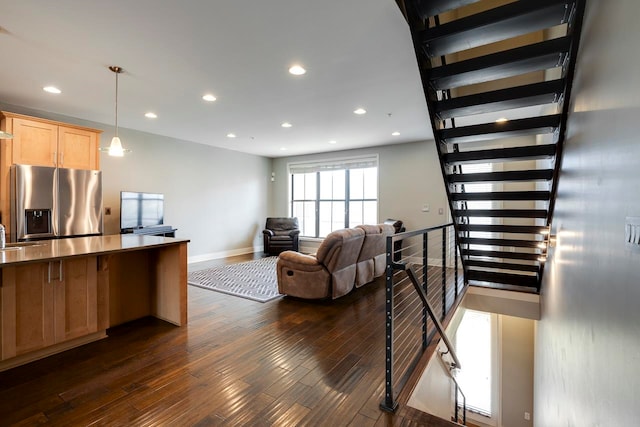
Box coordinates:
[356,224,395,288]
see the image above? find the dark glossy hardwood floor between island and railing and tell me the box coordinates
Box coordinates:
[0,255,458,426]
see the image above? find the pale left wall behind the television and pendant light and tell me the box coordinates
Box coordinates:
[0,105,272,261]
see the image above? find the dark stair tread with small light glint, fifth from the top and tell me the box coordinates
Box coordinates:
[436,114,561,144]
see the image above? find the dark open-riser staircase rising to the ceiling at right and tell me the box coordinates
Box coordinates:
[397,0,585,292]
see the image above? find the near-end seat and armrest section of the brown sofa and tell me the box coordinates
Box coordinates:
[276,228,364,299]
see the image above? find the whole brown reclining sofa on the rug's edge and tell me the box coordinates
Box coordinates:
[276,224,395,299]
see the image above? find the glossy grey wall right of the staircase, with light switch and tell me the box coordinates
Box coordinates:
[535,0,640,427]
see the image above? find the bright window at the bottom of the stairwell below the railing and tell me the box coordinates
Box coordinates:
[455,310,495,417]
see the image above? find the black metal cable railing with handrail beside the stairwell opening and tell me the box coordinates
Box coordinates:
[380,223,465,411]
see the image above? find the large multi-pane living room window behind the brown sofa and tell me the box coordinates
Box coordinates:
[289,157,378,237]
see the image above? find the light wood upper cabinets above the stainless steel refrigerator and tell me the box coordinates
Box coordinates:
[0,112,102,169]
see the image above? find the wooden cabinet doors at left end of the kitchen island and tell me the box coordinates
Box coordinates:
[0,256,100,360]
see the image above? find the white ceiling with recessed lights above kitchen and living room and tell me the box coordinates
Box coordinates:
[0,0,432,157]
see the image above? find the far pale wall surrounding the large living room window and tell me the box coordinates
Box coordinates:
[271,141,449,234]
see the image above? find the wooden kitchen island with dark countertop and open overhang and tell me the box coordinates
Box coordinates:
[0,234,189,371]
